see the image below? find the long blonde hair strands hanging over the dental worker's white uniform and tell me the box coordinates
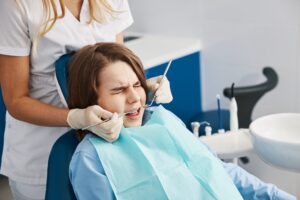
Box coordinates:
[33,0,118,49]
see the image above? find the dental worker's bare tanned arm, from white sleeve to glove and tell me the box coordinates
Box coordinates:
[0,55,68,126]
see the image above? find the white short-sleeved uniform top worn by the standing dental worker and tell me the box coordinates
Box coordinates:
[0,0,133,184]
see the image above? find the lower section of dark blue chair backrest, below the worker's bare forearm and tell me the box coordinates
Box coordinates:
[45,130,79,200]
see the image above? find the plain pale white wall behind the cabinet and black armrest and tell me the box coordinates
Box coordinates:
[129,0,300,118]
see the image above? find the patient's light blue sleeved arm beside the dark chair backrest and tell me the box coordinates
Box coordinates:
[70,135,115,200]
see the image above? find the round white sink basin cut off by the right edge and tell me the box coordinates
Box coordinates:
[249,113,300,172]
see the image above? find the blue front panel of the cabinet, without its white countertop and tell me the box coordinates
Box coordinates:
[146,51,202,127]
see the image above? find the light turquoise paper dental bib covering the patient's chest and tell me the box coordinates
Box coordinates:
[90,106,242,200]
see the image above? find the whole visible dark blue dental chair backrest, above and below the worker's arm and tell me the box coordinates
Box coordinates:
[45,53,79,200]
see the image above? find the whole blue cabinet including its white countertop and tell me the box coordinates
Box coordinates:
[126,35,202,128]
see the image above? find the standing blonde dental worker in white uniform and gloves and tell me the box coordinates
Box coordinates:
[0,0,172,200]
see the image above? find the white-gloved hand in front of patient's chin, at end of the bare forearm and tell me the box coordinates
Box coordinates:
[67,105,123,142]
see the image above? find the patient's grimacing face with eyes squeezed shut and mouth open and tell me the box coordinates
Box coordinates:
[98,61,146,127]
